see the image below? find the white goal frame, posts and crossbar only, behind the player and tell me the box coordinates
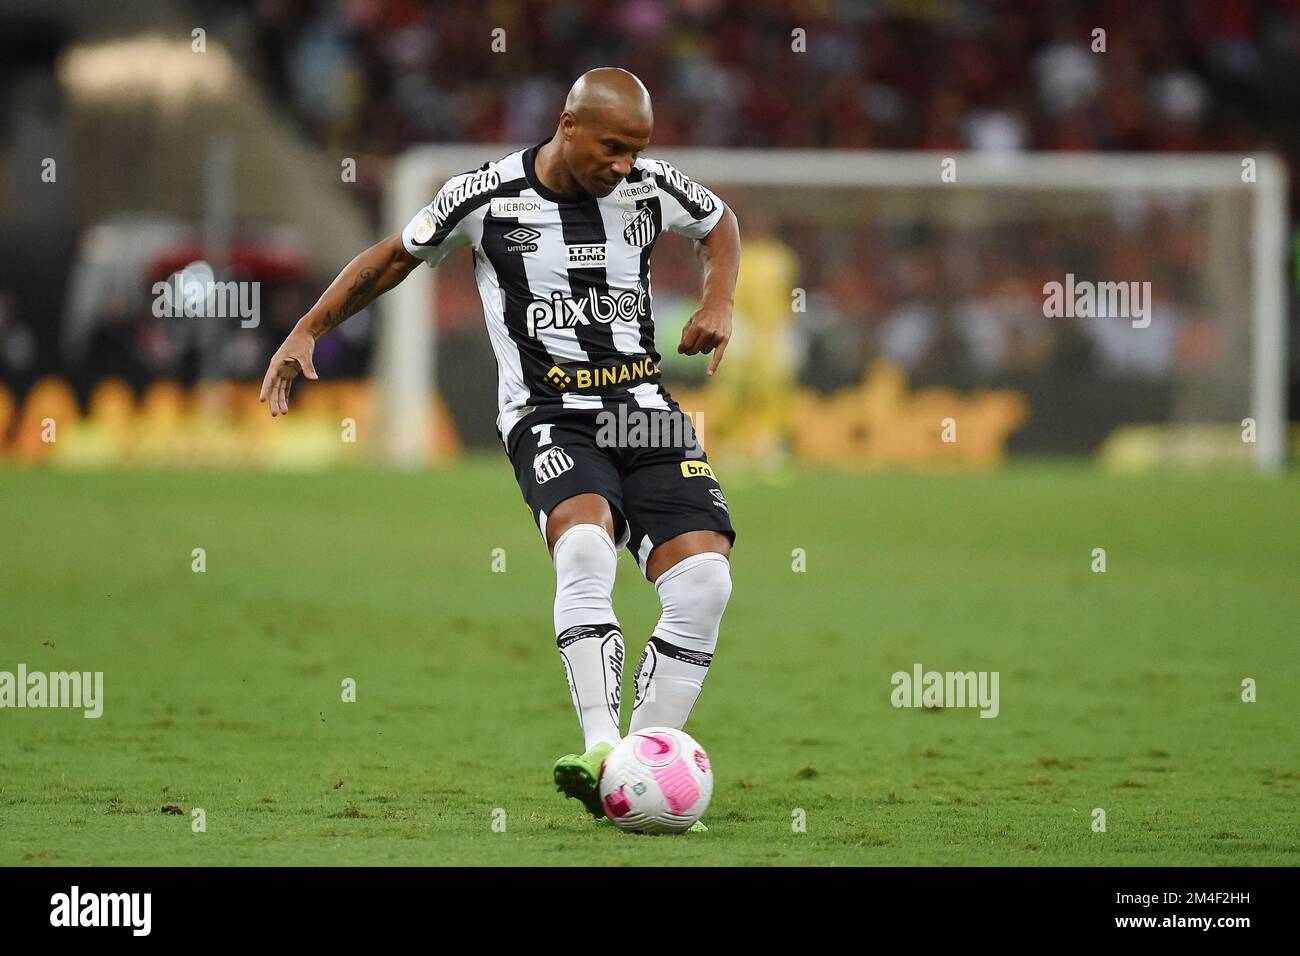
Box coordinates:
[373,144,1288,472]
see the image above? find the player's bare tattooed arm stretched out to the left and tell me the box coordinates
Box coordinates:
[257,233,420,416]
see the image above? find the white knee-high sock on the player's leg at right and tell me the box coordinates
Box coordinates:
[629,551,731,732]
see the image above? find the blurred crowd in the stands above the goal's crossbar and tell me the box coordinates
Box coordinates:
[233,0,1300,153]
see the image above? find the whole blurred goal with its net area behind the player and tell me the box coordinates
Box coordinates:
[373,144,1287,470]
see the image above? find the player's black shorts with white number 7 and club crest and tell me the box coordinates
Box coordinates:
[507,401,736,574]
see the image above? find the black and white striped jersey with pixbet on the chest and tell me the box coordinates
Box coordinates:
[402,134,724,442]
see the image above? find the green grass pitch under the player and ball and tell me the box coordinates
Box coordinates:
[0,455,1300,865]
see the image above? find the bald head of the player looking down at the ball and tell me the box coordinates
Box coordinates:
[545,66,654,196]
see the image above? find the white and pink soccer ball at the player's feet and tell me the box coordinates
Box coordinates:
[601,727,714,834]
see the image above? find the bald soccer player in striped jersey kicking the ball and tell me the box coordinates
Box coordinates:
[260,68,740,832]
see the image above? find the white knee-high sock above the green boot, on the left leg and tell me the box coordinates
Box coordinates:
[551,524,625,750]
